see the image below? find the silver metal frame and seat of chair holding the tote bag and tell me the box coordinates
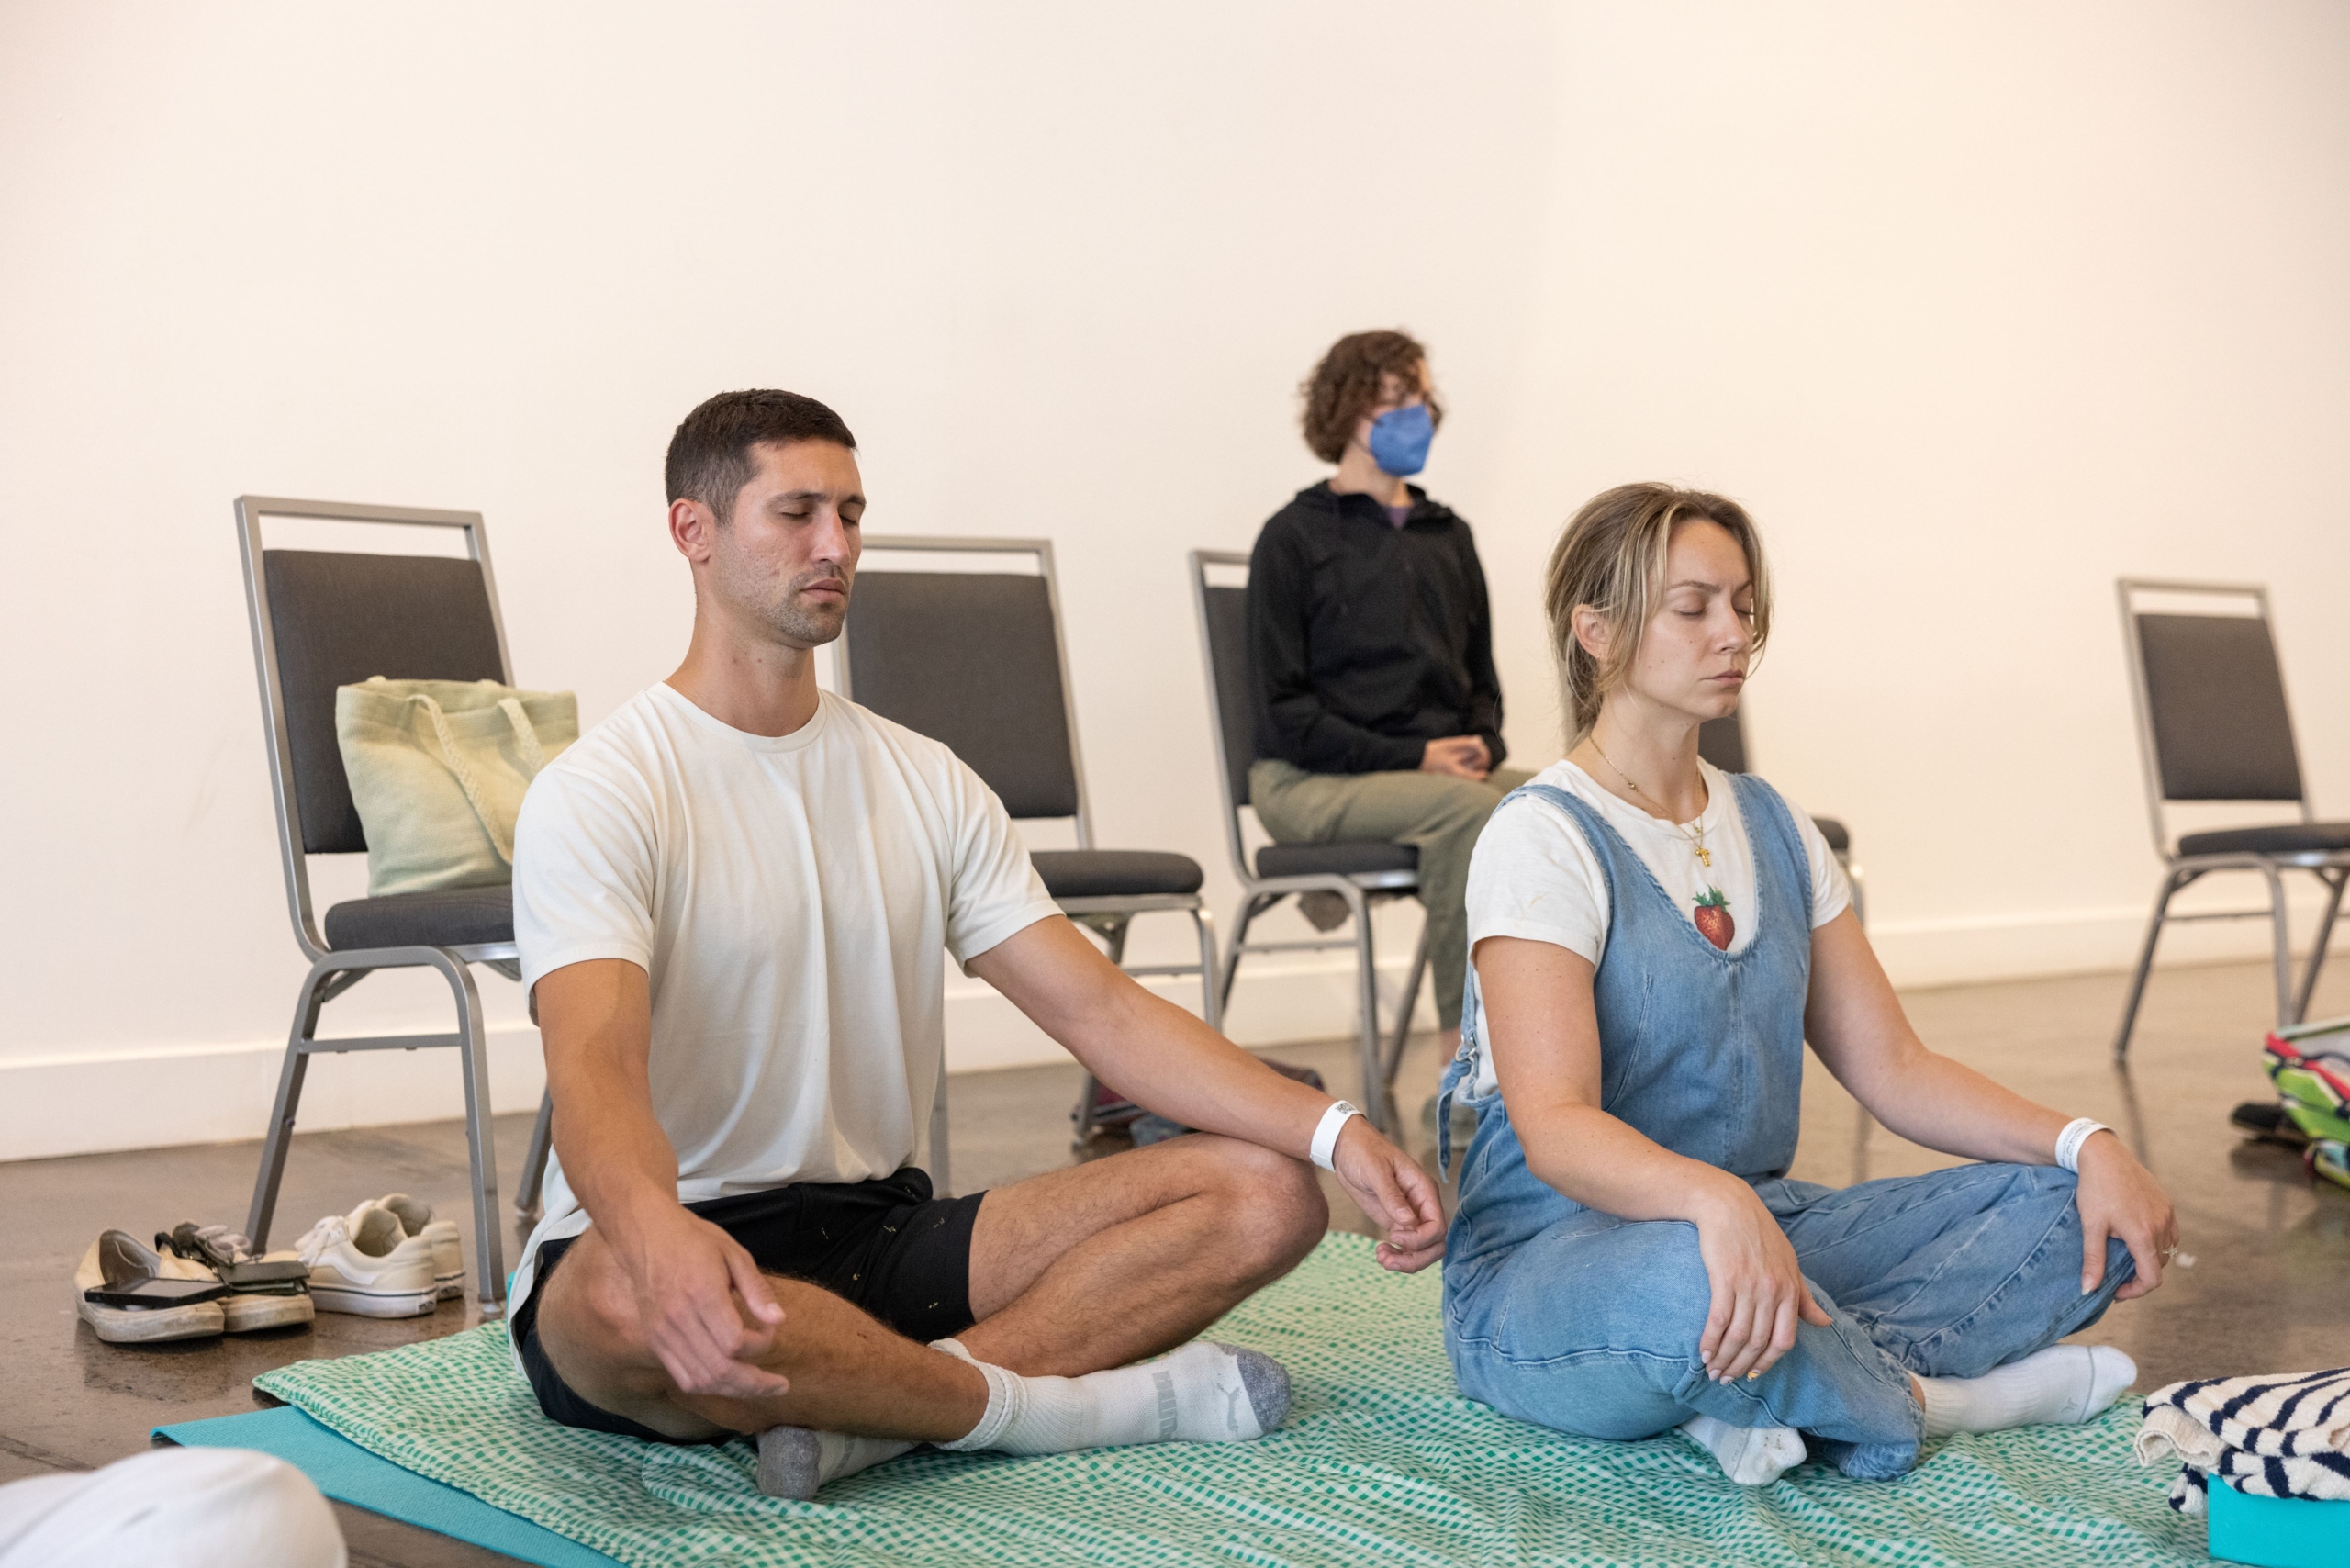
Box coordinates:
[235,496,523,1316]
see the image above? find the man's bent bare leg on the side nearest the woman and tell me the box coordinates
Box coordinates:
[957,1133,1330,1378]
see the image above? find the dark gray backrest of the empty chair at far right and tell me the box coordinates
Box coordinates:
[2133,613,2300,801]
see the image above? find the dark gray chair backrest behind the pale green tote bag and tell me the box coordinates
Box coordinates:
[261,550,512,856]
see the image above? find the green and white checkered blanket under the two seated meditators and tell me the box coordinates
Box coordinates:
[256,1234,2207,1568]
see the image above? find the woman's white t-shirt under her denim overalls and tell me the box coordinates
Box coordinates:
[1469,759,1852,1093]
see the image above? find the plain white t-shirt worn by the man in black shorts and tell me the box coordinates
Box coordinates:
[512,684,1058,1307]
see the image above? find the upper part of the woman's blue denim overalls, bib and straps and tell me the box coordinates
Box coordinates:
[1436,773,1812,1250]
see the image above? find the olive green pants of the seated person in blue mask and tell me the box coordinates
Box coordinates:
[1248,759,1532,1030]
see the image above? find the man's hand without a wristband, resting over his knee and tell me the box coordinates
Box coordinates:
[609,1196,792,1399]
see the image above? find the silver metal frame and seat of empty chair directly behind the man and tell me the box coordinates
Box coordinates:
[832,533,1225,1160]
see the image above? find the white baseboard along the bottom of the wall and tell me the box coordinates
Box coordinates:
[0,905,2343,1159]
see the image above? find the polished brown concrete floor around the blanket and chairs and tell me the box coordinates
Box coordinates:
[0,964,2350,1568]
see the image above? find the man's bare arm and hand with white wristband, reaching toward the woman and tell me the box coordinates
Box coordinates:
[968,917,1445,1270]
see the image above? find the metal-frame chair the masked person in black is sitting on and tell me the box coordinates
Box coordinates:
[1192,550,1428,1136]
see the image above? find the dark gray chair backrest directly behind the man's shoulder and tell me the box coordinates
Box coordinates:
[841,566,1083,818]
